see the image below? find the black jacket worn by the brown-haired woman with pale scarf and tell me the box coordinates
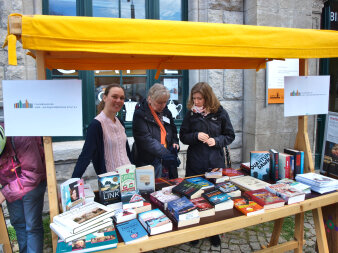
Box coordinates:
[180,106,235,176]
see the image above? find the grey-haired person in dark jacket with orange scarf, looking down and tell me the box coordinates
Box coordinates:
[132,83,179,178]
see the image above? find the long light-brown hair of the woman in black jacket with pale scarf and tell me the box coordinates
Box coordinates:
[187,82,221,113]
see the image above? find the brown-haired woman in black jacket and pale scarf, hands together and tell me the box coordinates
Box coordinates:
[180,82,235,246]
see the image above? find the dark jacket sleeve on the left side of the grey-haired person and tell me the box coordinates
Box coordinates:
[133,110,169,157]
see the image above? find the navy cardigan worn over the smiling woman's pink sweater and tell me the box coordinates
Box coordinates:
[72,119,130,178]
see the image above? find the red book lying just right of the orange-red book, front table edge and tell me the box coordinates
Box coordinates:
[244,189,285,210]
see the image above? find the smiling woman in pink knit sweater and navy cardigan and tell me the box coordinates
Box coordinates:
[72,84,130,178]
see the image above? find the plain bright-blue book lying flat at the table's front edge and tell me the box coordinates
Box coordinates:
[116,219,148,244]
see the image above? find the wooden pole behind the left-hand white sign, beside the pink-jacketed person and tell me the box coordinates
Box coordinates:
[36,51,59,252]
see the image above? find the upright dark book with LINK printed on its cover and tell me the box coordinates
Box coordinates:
[97,171,121,205]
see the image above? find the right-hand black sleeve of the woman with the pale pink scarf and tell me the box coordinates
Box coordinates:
[214,109,235,148]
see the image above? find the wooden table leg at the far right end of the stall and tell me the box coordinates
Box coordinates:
[312,208,329,253]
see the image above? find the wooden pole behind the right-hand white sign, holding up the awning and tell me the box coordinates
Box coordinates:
[294,59,315,172]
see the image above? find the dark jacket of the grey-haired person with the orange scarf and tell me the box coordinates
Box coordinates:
[133,99,178,166]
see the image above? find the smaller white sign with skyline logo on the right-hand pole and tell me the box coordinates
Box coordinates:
[284,76,330,117]
